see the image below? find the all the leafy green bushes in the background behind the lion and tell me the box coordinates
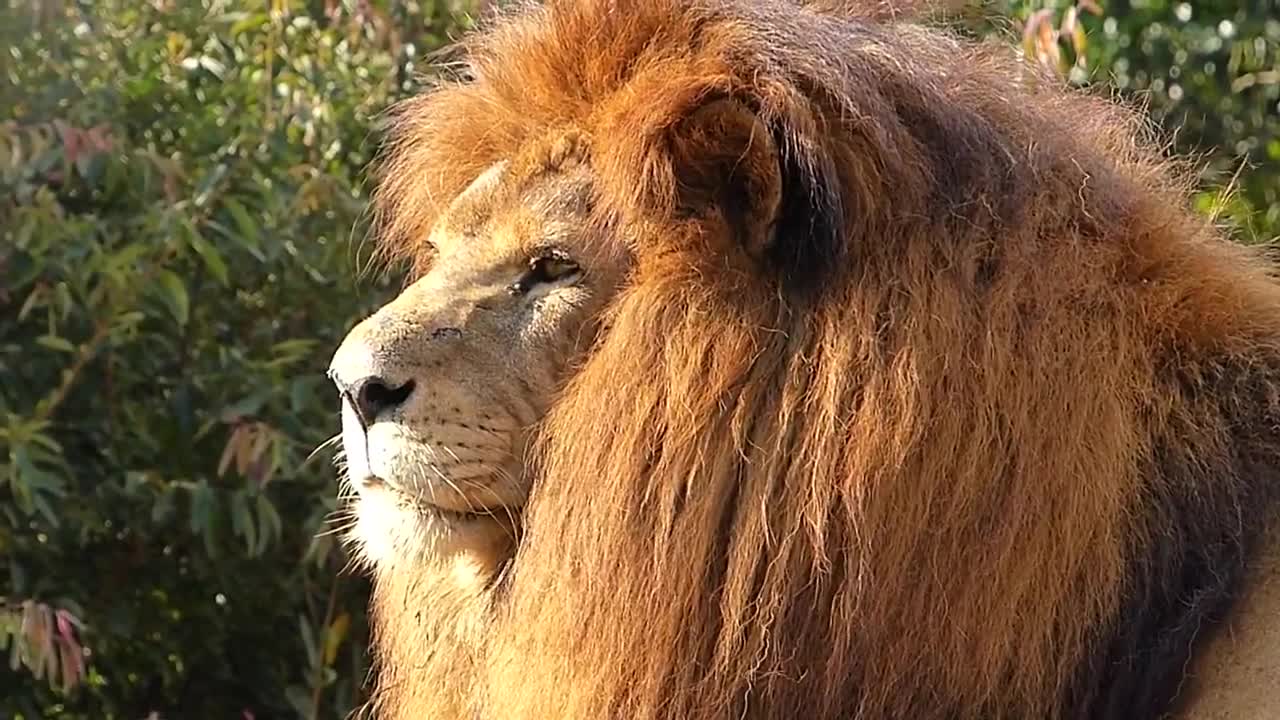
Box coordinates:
[0,0,1280,720]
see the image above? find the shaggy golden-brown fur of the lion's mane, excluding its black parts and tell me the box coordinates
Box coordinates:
[335,0,1280,720]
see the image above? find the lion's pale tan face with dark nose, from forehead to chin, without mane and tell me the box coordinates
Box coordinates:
[329,151,626,564]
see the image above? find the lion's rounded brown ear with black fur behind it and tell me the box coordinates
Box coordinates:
[668,97,842,288]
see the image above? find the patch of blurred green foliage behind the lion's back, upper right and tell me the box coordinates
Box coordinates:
[972,0,1280,242]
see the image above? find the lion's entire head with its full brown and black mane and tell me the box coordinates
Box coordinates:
[332,0,1280,720]
